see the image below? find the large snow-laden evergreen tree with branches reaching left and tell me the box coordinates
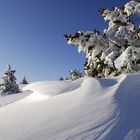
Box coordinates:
[64,1,140,77]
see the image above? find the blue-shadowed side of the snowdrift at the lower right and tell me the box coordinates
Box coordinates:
[107,74,140,140]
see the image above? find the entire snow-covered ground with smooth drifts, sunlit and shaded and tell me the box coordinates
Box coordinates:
[0,74,140,140]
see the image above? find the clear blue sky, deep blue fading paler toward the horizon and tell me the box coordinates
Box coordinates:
[0,0,127,81]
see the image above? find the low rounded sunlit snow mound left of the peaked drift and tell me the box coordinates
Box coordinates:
[24,79,83,96]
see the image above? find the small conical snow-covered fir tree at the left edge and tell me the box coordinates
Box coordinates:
[0,65,19,94]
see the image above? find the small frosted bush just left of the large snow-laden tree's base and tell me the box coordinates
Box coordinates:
[69,69,82,80]
